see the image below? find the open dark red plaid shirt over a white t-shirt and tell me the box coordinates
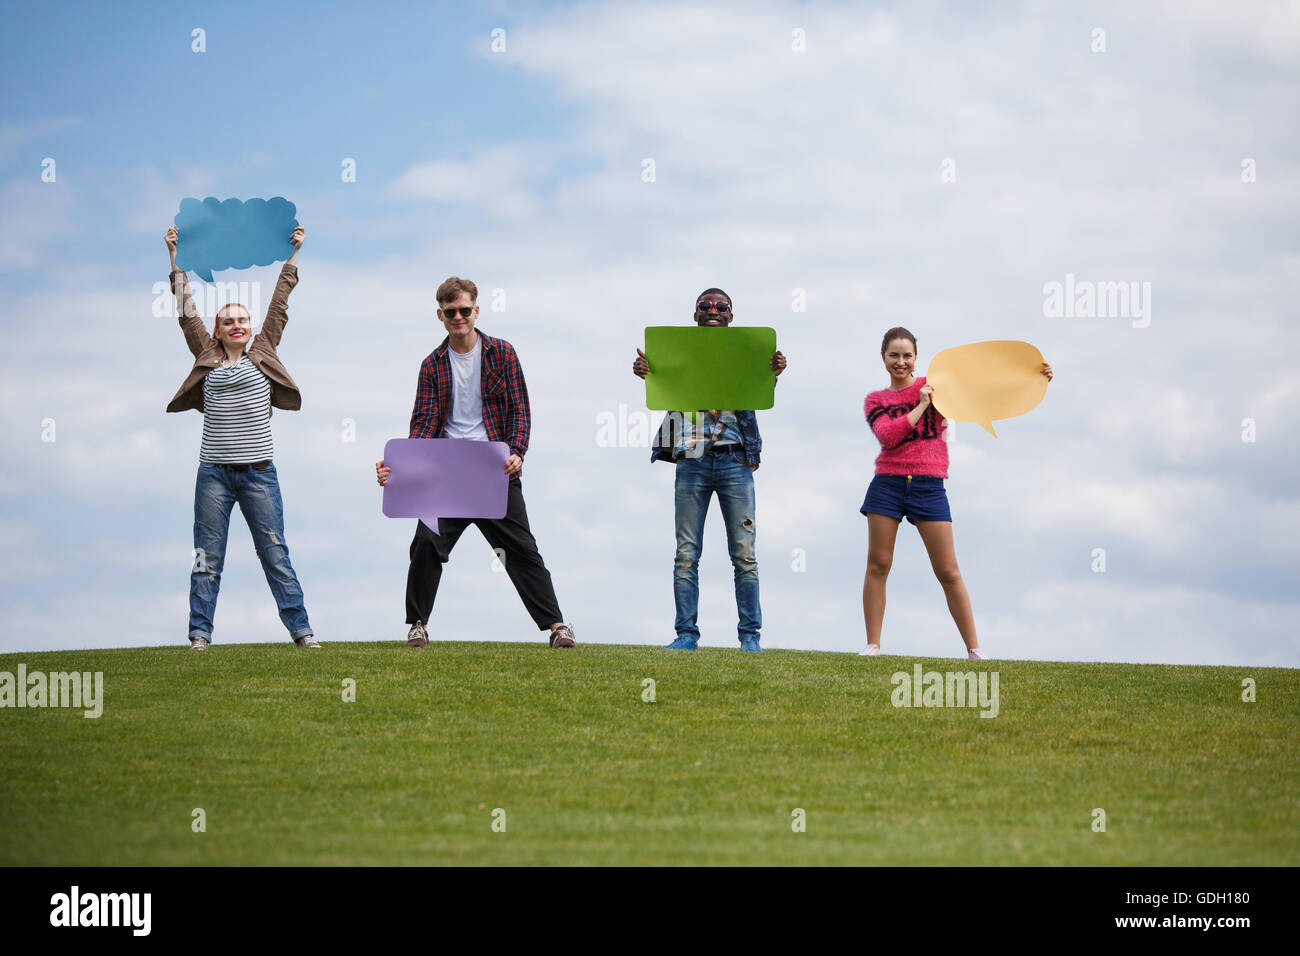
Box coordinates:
[410,332,533,470]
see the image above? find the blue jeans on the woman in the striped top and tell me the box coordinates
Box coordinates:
[190,464,312,641]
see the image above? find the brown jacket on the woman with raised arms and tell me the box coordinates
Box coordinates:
[166,263,303,411]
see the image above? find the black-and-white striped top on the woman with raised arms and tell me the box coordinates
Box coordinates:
[199,352,272,464]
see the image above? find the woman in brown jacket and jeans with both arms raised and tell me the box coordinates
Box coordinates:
[164,226,320,650]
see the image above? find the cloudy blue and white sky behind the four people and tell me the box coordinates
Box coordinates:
[0,1,1300,667]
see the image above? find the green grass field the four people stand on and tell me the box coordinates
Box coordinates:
[0,641,1300,865]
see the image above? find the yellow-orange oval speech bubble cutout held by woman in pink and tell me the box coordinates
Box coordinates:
[926,339,1048,438]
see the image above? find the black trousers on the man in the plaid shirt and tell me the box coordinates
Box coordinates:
[407,479,564,631]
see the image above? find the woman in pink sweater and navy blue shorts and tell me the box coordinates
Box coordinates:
[861,328,1052,661]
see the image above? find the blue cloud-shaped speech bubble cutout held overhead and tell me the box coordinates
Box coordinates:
[174,196,298,282]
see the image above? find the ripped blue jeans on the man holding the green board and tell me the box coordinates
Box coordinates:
[672,449,763,640]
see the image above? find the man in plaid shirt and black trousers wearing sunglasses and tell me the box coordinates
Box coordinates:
[374,276,575,648]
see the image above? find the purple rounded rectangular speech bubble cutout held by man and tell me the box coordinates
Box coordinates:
[384,438,510,535]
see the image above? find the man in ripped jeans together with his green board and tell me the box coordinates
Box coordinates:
[632,289,785,652]
